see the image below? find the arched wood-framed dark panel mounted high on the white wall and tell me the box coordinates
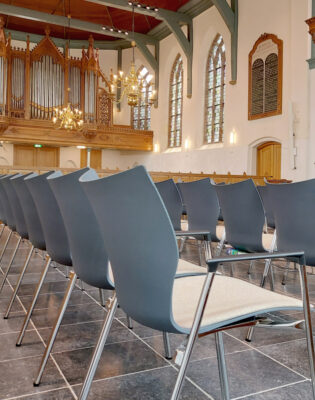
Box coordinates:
[248,33,283,120]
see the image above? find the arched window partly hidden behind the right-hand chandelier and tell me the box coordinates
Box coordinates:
[131,66,152,130]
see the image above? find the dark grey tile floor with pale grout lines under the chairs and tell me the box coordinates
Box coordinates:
[0,231,315,400]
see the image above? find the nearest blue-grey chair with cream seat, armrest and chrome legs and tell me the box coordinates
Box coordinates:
[79,166,314,400]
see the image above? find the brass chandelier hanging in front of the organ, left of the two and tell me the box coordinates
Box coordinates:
[52,5,83,130]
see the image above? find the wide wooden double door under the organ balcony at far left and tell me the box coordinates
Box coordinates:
[13,144,59,168]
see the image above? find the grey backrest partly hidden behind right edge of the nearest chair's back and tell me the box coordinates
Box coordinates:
[155,179,183,231]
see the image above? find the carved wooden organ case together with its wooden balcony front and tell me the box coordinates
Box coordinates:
[0,17,153,151]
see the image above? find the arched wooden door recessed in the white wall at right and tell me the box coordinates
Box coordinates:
[257,142,281,179]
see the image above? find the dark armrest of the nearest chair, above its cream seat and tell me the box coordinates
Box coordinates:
[206,251,305,272]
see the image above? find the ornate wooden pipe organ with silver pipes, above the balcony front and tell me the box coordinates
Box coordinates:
[0,23,112,125]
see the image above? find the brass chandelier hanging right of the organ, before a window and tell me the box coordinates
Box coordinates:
[110,2,156,107]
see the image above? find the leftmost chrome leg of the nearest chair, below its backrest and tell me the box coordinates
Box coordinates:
[78,293,117,400]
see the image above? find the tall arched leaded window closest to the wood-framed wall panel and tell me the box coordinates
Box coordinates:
[204,34,226,143]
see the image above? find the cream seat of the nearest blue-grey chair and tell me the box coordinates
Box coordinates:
[172,275,303,333]
